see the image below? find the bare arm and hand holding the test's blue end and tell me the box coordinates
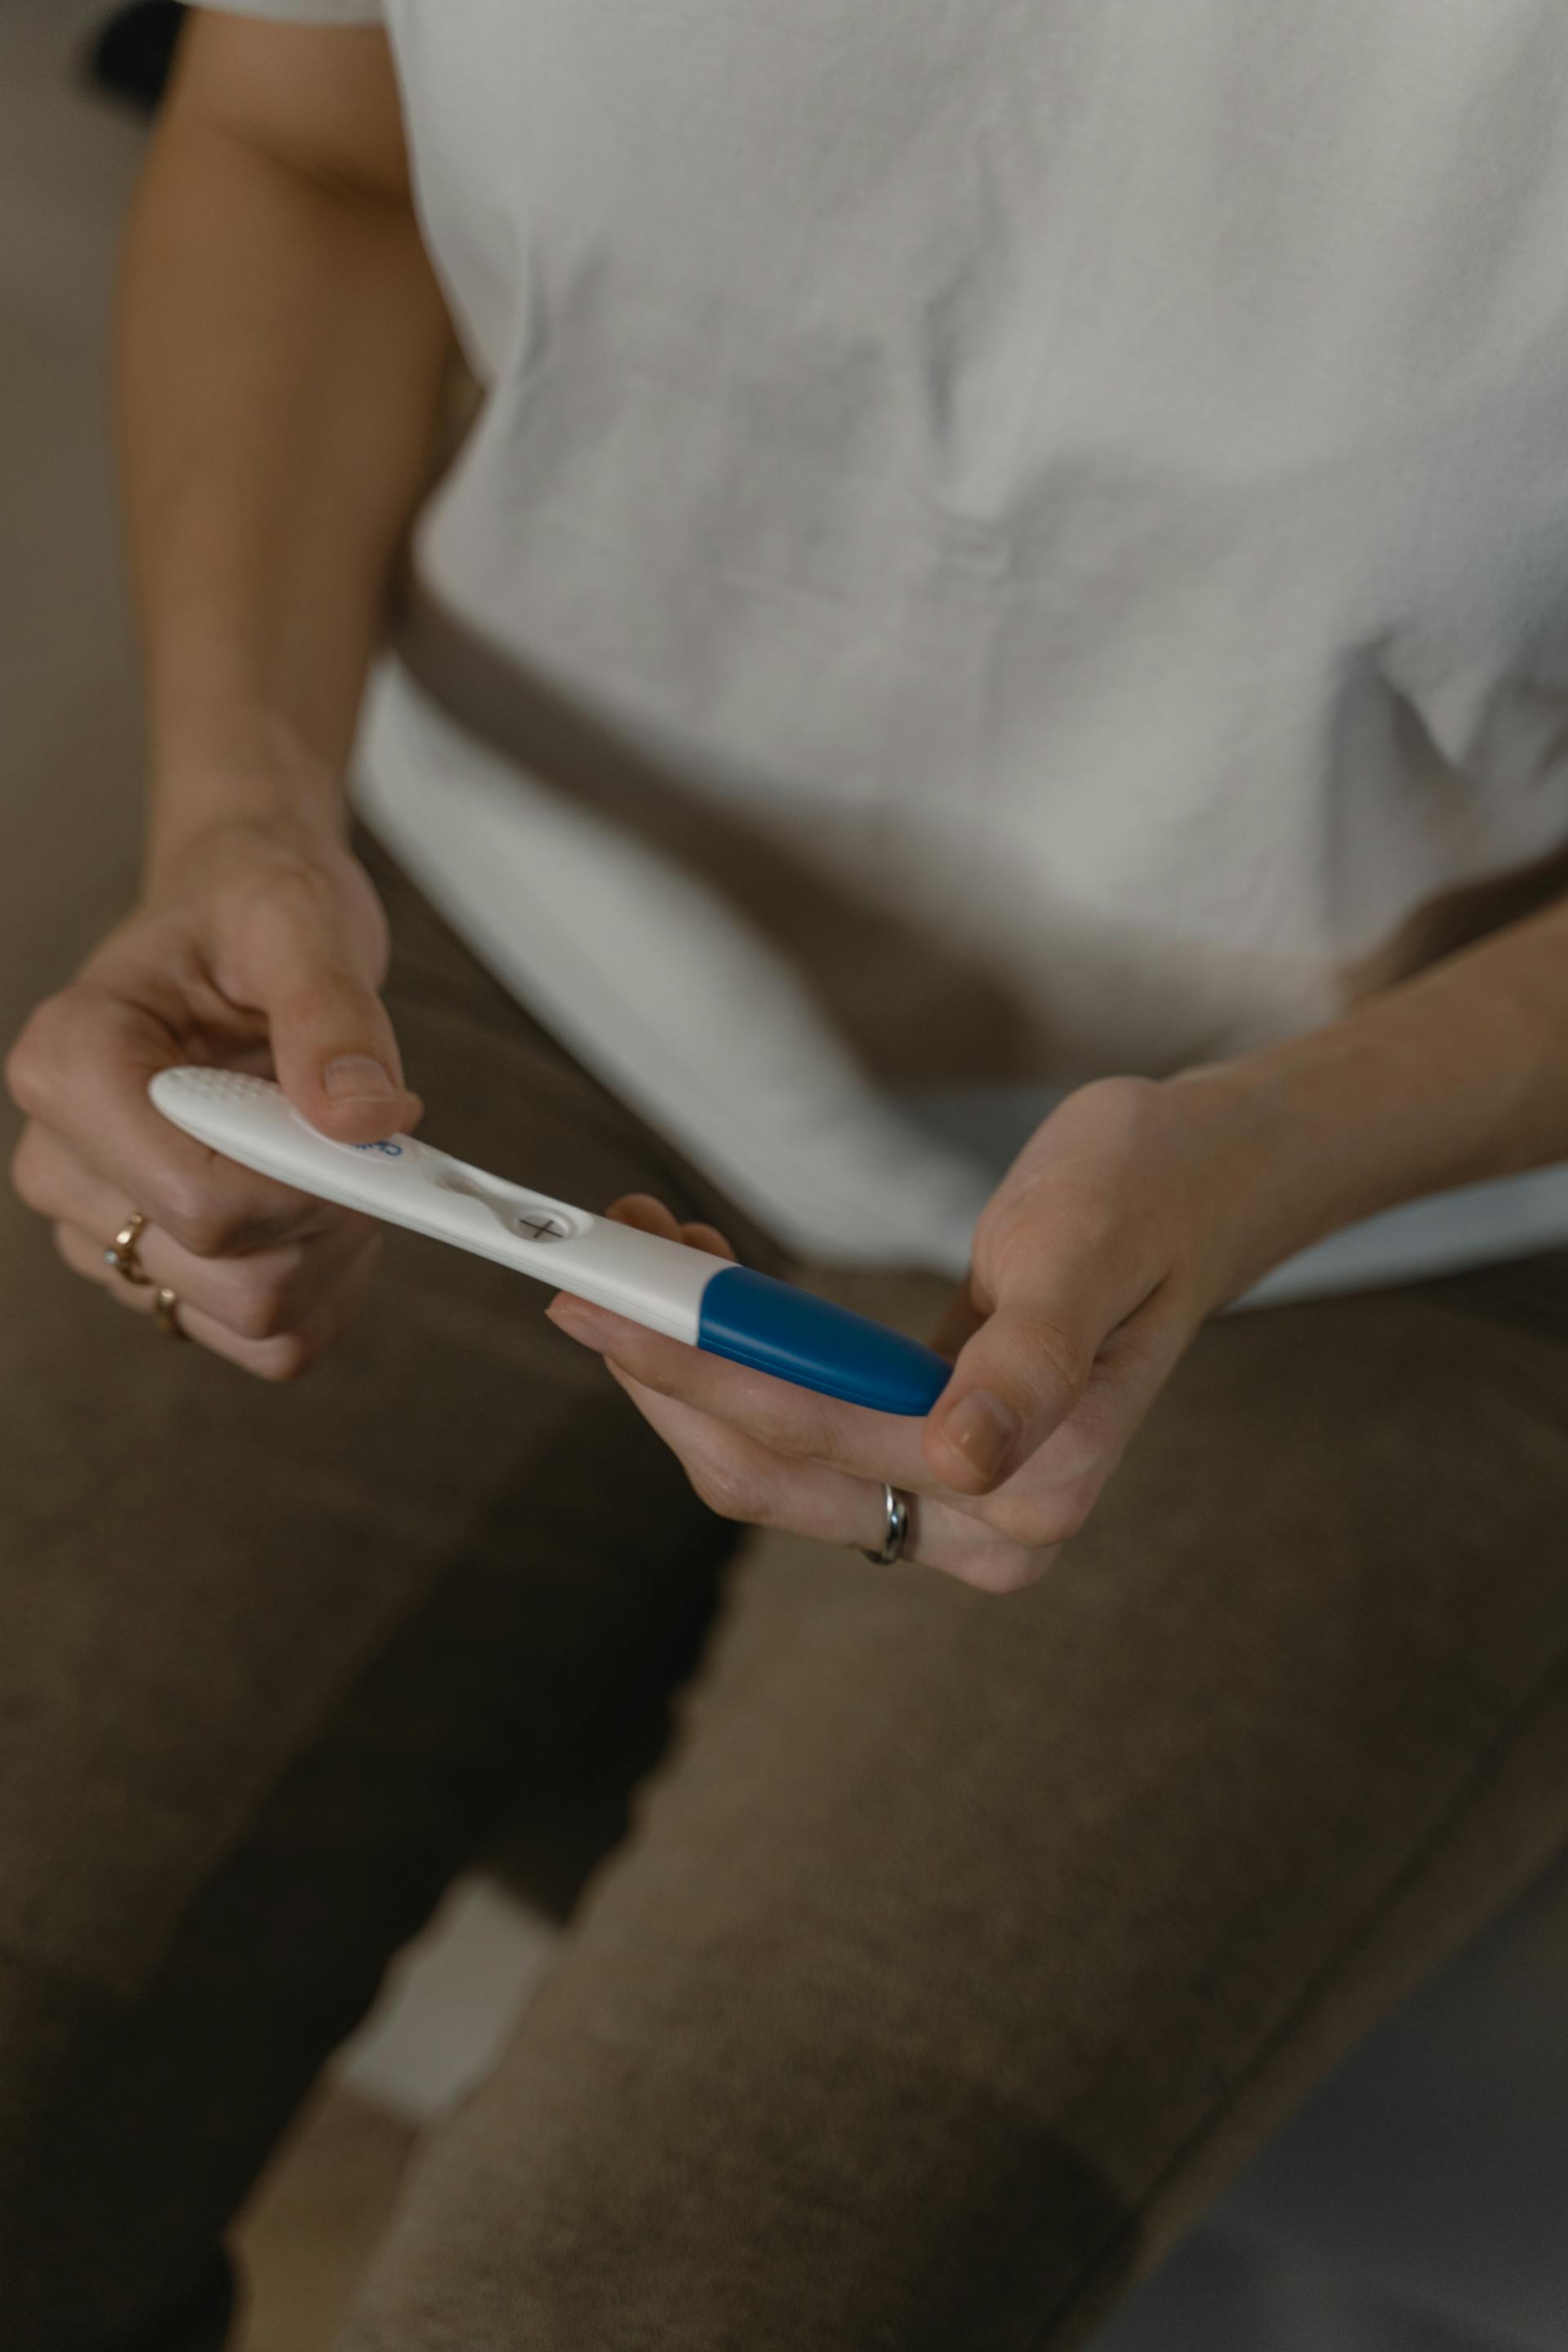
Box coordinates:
[550,906,1568,1592]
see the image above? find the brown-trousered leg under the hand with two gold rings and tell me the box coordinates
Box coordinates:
[0,846,780,2352]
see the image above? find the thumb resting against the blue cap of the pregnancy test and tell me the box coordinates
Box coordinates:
[924,1251,1138,1494]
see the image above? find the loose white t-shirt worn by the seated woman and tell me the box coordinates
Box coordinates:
[202,0,1568,1298]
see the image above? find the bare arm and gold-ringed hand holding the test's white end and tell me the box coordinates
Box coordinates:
[7,11,449,1379]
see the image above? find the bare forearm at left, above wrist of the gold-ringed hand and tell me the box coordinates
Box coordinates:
[120,60,449,884]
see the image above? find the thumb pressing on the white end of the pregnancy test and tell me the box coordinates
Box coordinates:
[233,880,421,1143]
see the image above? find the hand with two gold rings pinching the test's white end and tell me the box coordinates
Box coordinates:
[7,823,421,1381]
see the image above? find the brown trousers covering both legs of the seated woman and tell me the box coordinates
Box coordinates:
[0,837,1568,2352]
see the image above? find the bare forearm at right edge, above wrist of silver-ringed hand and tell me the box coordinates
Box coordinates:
[1173,884,1568,1286]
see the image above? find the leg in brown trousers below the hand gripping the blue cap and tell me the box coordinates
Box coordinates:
[345,1258,1568,2352]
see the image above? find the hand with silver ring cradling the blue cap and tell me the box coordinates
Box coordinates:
[550,1072,1263,1592]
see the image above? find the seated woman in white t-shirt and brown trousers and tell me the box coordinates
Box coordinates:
[0,0,1568,2352]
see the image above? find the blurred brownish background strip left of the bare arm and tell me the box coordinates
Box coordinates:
[0,0,144,1040]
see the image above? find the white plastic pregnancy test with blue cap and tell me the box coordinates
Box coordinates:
[148,1068,952,1414]
